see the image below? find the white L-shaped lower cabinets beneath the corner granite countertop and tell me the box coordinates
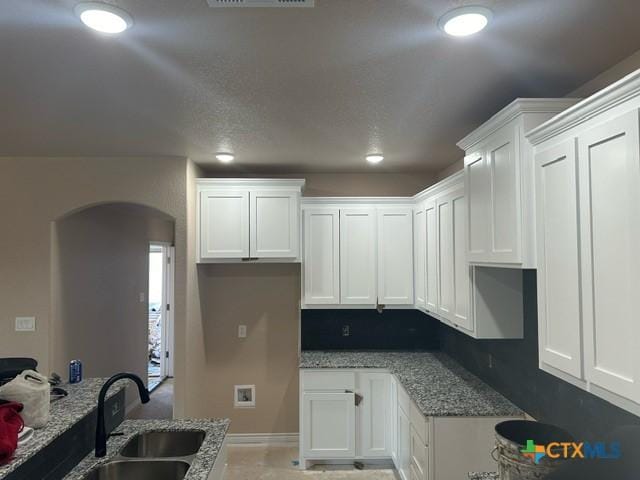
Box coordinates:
[300,369,513,480]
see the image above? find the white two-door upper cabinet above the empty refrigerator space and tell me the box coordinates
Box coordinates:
[196,178,304,262]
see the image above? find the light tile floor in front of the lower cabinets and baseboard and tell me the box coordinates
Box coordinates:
[224,446,398,480]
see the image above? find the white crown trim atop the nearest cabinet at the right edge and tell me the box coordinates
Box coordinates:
[526,69,640,145]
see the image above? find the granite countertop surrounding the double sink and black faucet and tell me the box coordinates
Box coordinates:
[64,419,230,480]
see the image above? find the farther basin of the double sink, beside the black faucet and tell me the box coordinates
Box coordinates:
[120,430,204,458]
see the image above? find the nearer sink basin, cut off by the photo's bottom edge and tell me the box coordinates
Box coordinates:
[84,460,189,480]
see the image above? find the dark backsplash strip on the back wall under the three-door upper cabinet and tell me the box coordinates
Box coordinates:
[301,310,438,350]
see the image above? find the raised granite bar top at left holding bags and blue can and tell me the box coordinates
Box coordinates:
[0,378,127,479]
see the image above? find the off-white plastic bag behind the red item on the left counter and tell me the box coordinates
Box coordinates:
[0,370,51,428]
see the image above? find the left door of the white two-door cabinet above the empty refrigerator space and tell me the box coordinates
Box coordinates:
[200,190,249,259]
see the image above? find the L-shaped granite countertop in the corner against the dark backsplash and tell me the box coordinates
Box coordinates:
[300,351,524,417]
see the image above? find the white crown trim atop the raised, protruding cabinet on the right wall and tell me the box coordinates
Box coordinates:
[456,98,580,152]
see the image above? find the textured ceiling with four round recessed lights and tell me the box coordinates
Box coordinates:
[0,0,640,173]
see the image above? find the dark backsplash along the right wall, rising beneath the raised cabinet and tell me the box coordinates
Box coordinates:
[439,270,640,440]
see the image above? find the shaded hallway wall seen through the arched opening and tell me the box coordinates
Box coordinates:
[50,203,175,398]
